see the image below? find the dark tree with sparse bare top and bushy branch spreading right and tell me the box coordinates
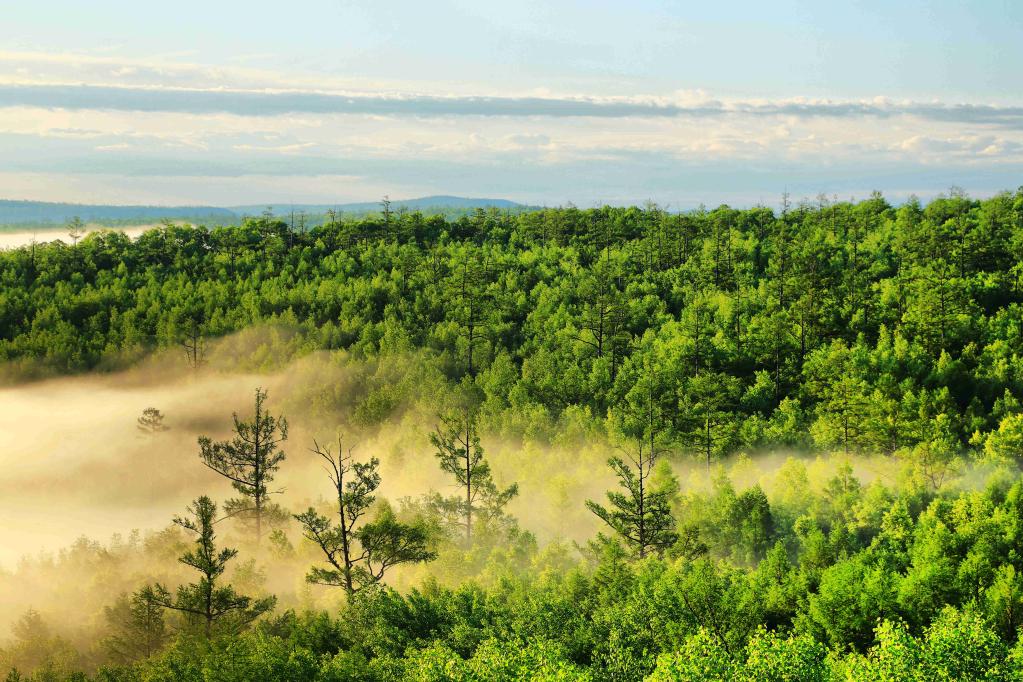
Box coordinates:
[295,437,436,600]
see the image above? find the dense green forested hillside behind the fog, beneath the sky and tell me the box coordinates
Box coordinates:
[6,192,1023,459]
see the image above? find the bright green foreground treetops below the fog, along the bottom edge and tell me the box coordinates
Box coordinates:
[14,478,1023,682]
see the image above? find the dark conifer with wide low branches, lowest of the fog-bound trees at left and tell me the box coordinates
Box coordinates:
[138,495,277,639]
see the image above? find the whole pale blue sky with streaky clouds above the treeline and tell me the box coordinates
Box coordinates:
[0,0,1023,208]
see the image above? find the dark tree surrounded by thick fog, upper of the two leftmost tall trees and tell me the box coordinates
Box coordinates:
[198,389,287,547]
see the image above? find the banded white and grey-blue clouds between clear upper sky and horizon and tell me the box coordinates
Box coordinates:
[0,52,1023,206]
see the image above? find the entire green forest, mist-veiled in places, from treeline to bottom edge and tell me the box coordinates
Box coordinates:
[0,188,1023,682]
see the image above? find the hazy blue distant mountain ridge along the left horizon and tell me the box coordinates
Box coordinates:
[0,195,526,226]
